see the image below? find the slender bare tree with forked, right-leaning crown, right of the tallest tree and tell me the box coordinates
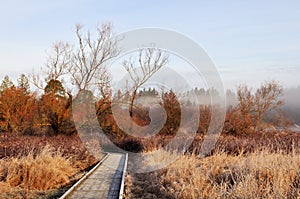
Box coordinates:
[122,48,169,117]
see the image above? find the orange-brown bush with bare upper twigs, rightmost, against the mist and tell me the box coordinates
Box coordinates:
[224,81,283,135]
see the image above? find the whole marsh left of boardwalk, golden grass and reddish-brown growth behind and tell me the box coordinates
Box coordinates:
[0,135,97,199]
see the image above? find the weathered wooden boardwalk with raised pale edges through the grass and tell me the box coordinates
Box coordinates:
[62,153,127,199]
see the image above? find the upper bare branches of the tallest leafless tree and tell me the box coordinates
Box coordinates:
[68,23,118,90]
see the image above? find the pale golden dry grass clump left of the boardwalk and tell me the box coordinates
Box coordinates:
[0,146,76,198]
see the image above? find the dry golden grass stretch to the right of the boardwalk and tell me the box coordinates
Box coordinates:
[126,149,300,199]
